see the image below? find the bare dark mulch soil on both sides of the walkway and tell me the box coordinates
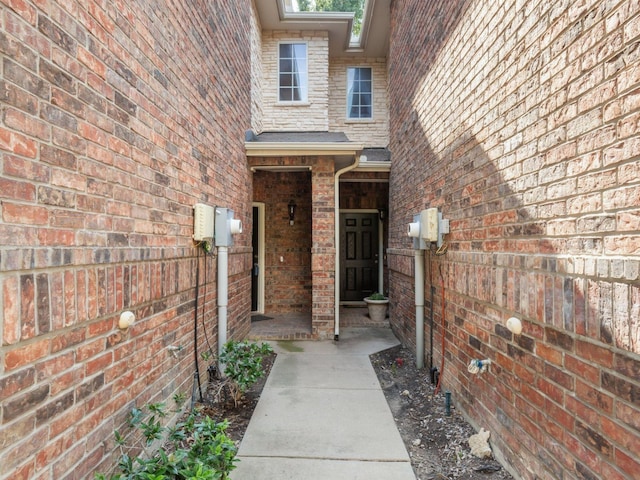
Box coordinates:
[201,346,513,480]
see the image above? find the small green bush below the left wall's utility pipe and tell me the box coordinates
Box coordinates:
[220,340,273,406]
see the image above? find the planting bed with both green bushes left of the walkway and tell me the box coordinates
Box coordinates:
[95,341,273,480]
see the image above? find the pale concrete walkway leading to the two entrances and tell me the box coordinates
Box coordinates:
[231,328,416,480]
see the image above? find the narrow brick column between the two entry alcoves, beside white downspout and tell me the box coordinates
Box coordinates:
[311,157,336,338]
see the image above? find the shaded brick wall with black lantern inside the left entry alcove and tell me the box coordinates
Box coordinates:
[253,171,311,314]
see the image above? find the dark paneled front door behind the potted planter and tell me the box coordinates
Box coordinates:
[340,213,378,302]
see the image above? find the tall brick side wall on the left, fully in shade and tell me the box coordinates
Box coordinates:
[0,0,251,479]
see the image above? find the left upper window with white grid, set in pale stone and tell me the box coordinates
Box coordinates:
[278,43,308,102]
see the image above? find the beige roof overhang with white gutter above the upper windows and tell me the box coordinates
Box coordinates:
[255,0,391,57]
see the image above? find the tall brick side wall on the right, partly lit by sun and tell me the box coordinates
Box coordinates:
[389,0,640,479]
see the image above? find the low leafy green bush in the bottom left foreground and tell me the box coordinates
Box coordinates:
[95,403,237,480]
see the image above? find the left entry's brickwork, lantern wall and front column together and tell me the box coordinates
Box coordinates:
[249,157,336,338]
